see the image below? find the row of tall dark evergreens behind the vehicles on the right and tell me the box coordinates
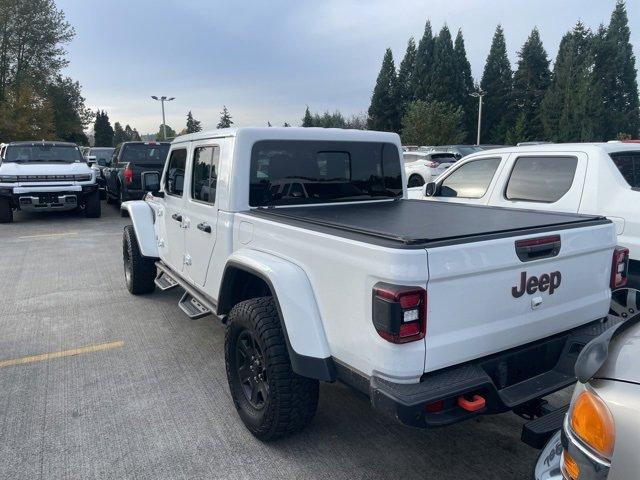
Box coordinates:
[368,1,640,145]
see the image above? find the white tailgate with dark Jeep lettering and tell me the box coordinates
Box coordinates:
[425,224,616,372]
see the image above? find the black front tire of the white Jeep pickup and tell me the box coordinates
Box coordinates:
[122,225,156,295]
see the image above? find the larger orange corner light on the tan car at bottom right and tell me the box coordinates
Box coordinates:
[569,390,616,460]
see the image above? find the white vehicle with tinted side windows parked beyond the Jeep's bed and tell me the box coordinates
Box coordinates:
[410,143,640,292]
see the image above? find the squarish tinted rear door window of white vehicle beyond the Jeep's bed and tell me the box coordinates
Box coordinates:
[505,157,578,203]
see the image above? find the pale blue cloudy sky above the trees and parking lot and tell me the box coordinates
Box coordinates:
[56,0,640,133]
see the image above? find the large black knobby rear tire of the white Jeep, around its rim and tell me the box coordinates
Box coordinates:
[225,297,319,441]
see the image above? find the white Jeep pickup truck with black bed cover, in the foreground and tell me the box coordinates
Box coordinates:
[122,128,626,440]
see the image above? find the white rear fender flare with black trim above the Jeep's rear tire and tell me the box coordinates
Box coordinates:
[218,249,336,381]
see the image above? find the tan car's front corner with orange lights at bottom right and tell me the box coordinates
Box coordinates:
[531,315,640,480]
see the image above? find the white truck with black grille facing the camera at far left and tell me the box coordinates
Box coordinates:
[0,141,101,223]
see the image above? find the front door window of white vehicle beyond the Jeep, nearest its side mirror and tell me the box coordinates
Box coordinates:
[439,158,500,198]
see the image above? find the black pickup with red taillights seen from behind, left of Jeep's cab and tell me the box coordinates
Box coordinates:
[102,142,170,203]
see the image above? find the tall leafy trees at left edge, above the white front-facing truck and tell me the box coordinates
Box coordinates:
[0,0,93,143]
